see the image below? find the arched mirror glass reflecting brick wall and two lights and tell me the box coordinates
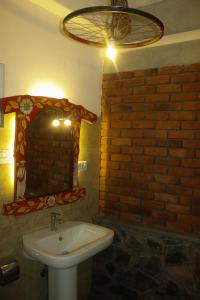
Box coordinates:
[25,109,74,198]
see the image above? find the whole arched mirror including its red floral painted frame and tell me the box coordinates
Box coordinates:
[2,95,97,216]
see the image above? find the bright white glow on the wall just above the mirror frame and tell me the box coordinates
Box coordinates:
[29,82,65,98]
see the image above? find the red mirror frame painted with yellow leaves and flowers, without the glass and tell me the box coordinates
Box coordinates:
[2,95,97,216]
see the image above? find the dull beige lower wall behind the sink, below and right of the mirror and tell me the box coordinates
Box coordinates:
[0,121,100,300]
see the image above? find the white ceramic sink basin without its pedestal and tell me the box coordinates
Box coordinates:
[23,222,114,269]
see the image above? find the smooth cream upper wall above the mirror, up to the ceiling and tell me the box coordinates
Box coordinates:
[0,0,102,115]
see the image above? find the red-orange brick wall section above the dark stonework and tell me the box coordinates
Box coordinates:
[100,64,200,233]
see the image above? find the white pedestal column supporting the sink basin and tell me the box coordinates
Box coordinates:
[48,266,77,300]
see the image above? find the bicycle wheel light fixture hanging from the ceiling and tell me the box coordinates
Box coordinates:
[62,0,164,48]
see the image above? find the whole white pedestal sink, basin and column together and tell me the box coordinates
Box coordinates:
[23,222,114,300]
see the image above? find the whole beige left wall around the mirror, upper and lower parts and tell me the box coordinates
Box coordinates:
[0,0,102,300]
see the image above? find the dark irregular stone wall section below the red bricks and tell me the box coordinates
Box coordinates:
[91,218,200,300]
